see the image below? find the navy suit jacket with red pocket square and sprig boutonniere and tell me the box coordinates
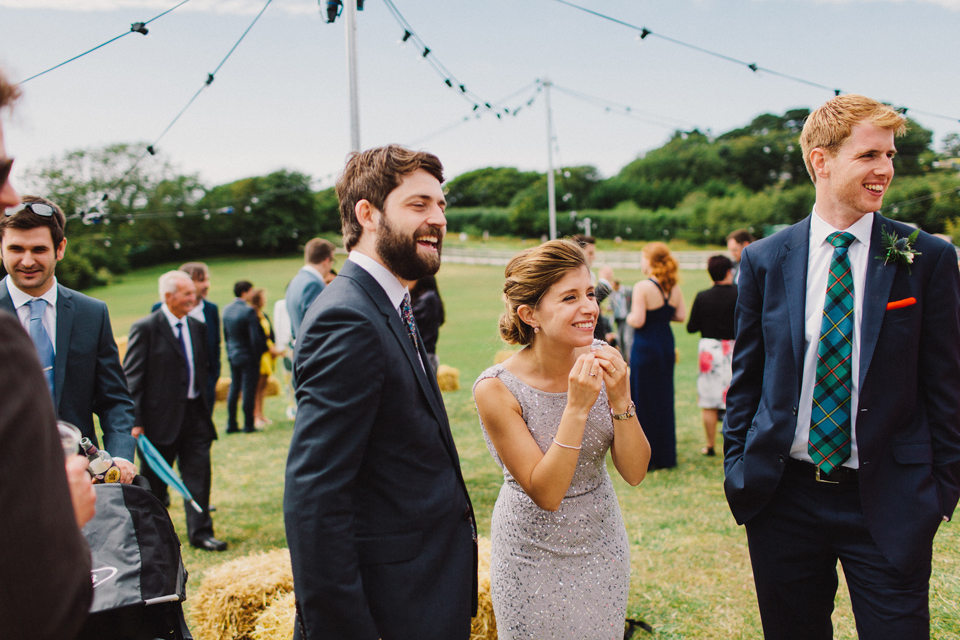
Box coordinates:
[724,214,960,572]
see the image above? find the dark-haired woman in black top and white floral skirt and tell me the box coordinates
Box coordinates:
[687,256,737,456]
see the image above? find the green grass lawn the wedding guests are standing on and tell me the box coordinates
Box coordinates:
[88,252,960,640]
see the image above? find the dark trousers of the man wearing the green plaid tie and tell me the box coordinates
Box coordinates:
[746,460,933,640]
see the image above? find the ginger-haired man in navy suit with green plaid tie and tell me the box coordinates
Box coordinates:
[724,95,960,640]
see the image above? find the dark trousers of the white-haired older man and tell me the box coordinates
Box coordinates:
[140,398,213,543]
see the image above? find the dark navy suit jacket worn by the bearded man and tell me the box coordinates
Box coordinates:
[284,260,477,640]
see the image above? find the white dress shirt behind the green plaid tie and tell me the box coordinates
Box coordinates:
[790,208,873,469]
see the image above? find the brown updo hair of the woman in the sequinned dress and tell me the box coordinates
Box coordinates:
[500,240,589,345]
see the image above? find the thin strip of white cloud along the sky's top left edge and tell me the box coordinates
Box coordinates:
[0,0,320,15]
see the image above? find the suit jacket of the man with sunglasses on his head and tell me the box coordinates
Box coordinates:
[0,285,137,462]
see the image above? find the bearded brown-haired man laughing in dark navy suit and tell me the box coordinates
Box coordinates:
[283,145,477,640]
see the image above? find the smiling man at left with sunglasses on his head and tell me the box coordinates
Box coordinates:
[0,196,136,483]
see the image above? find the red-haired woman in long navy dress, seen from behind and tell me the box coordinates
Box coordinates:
[627,242,687,471]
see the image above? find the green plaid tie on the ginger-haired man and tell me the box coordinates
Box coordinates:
[807,231,855,473]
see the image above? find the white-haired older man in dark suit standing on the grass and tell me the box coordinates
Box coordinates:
[123,271,227,551]
